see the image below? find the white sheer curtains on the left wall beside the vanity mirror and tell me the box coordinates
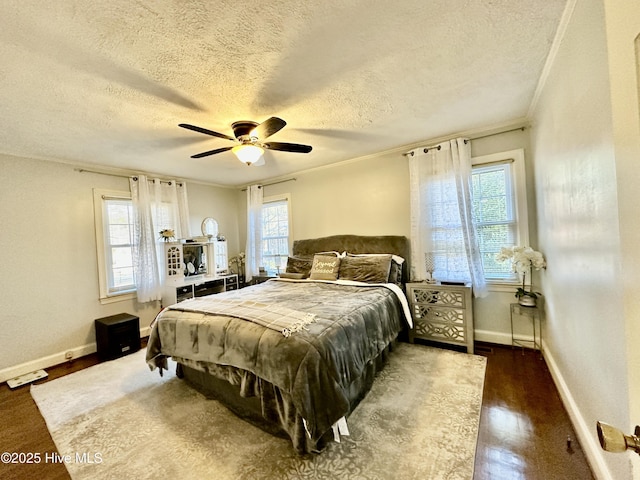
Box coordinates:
[129,175,191,303]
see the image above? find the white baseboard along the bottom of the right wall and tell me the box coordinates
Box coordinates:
[543,343,614,480]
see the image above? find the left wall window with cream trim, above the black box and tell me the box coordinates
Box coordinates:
[94,190,136,301]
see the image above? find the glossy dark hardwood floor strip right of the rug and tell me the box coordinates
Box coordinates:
[474,343,594,480]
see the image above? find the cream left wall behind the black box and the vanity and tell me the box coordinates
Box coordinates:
[0,155,238,382]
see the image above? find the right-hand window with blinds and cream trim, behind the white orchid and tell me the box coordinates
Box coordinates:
[471,150,529,282]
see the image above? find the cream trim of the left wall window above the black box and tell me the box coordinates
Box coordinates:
[93,188,136,304]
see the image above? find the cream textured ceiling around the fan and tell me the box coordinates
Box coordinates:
[0,0,566,185]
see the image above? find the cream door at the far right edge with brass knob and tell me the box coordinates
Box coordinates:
[601,0,640,479]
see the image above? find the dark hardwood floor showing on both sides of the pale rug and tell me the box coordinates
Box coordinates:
[0,344,593,480]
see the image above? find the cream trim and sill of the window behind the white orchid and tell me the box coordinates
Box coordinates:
[471,148,531,291]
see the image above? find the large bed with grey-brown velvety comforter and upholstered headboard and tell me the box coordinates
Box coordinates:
[147,235,411,454]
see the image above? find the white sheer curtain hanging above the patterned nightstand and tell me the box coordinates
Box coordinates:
[409,138,487,297]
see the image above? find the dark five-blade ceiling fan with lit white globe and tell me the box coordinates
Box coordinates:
[178,117,312,165]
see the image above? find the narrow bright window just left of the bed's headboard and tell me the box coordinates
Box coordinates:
[262,195,291,275]
